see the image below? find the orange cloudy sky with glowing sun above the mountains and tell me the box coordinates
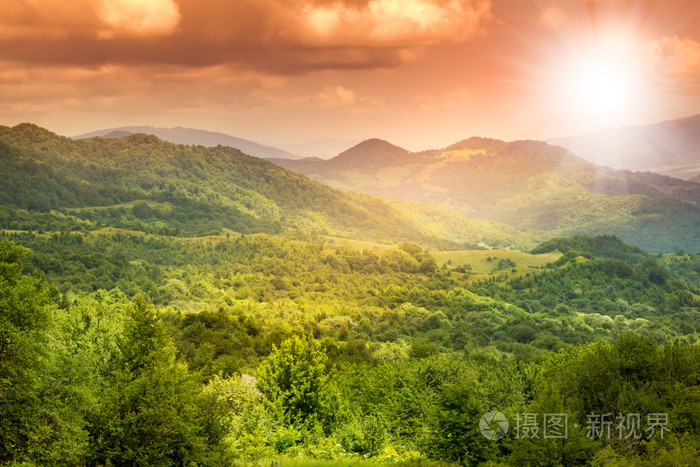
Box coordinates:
[0,0,700,150]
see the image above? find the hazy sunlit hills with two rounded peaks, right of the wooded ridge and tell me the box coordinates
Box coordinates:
[275,138,700,251]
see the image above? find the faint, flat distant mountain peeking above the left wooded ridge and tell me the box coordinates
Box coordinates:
[75,126,300,159]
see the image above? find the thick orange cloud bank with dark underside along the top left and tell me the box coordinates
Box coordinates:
[0,0,491,74]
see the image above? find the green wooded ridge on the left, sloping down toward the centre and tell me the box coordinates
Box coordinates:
[0,124,449,243]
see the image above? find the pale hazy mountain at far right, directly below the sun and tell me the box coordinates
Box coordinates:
[549,115,700,179]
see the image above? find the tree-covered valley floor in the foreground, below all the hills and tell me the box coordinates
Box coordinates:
[0,233,700,465]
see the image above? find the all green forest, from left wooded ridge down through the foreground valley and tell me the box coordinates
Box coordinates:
[0,126,700,466]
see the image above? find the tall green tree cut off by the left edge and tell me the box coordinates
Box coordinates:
[0,240,91,465]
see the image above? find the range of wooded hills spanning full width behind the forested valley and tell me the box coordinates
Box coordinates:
[5,120,700,252]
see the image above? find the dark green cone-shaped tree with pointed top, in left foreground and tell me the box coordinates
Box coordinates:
[90,296,204,466]
